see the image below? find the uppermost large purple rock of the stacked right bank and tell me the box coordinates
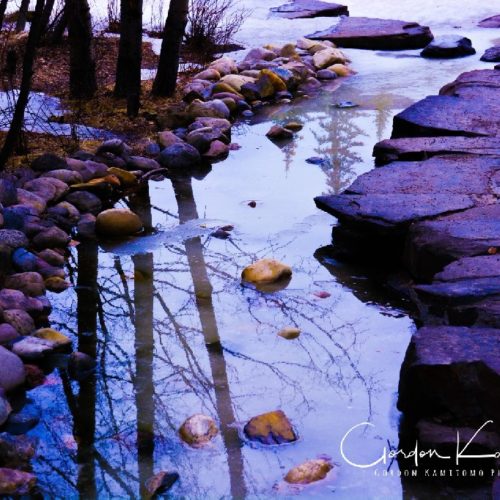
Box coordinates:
[392,70,500,139]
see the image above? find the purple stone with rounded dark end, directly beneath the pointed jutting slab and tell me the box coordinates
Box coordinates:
[405,204,500,281]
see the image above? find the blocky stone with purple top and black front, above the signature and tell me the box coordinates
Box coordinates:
[398,326,500,431]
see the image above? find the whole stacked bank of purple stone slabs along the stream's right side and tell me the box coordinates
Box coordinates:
[316,70,500,490]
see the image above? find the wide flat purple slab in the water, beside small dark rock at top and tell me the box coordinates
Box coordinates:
[307,17,434,50]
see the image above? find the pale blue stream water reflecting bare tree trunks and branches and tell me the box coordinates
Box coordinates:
[13,0,500,498]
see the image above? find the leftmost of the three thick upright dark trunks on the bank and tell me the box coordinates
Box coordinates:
[65,0,97,99]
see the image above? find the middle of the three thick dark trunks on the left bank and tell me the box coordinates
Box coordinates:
[115,0,142,116]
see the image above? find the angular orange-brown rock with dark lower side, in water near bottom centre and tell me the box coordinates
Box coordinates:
[243,410,298,445]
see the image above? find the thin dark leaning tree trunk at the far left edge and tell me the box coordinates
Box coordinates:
[0,0,45,170]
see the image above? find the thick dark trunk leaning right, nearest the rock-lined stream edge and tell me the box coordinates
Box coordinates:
[153,0,189,96]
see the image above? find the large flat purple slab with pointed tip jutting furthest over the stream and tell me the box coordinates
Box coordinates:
[315,155,500,232]
